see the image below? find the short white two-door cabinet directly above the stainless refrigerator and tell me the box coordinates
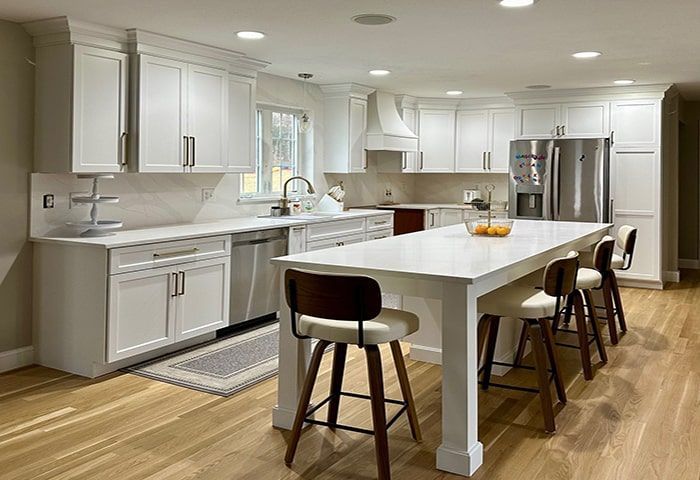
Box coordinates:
[516,102,610,139]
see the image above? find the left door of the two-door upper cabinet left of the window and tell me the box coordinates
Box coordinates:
[138,55,188,173]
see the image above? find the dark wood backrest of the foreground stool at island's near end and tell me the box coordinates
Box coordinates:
[284,269,382,321]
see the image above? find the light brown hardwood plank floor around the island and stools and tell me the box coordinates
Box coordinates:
[0,272,700,480]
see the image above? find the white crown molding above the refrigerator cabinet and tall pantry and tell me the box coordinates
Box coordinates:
[506,83,673,104]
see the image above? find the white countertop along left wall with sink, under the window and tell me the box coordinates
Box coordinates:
[30,209,386,248]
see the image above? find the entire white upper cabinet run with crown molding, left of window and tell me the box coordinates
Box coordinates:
[24,17,267,173]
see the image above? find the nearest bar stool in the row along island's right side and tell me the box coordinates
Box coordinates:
[477,252,578,433]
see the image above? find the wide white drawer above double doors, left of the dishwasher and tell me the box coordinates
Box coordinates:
[109,235,231,275]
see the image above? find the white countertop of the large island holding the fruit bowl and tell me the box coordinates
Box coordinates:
[272,220,612,283]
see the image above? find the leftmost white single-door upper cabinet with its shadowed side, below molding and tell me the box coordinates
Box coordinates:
[35,44,128,173]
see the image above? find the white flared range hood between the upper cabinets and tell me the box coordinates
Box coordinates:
[367,91,418,152]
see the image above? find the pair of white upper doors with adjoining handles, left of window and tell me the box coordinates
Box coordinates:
[138,55,229,173]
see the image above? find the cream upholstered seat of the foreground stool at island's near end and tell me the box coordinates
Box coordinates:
[299,308,418,345]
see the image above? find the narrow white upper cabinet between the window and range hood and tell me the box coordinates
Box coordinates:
[321,83,373,173]
